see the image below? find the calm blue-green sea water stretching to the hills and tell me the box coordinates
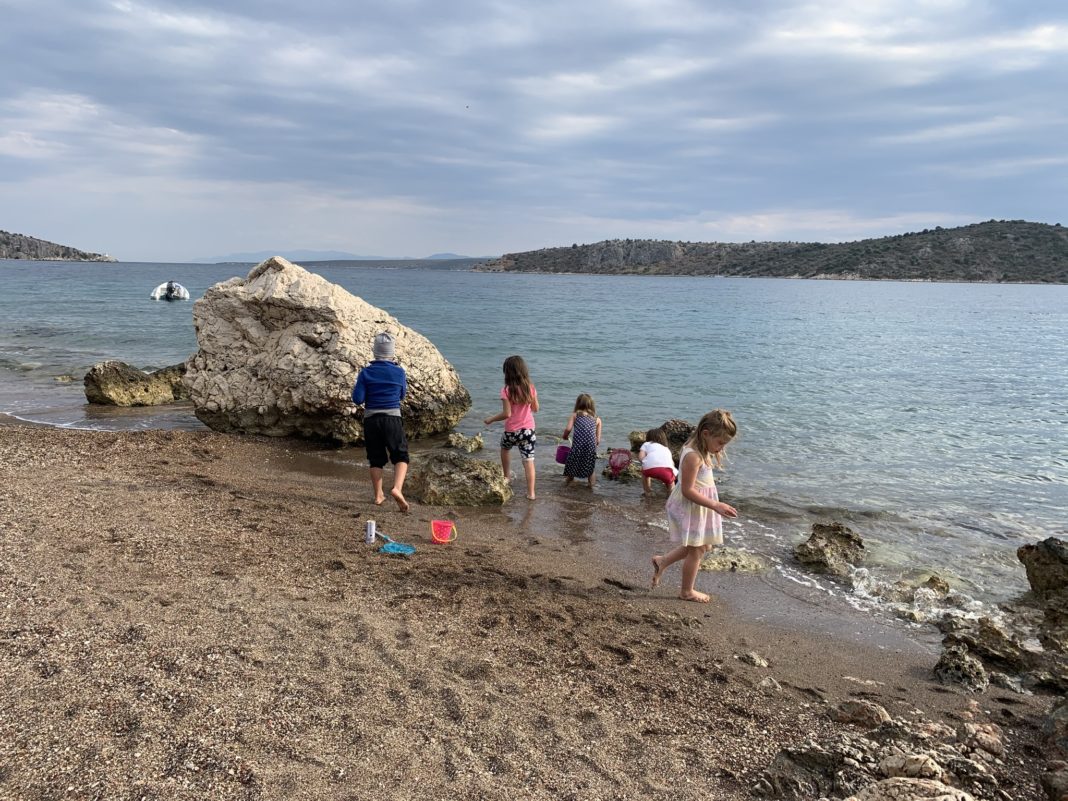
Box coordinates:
[0,261,1068,601]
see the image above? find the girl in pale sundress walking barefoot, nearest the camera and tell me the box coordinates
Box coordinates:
[653,409,738,603]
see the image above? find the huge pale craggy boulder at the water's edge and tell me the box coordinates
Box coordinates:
[185,256,471,443]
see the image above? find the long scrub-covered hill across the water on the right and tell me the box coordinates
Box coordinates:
[476,220,1068,284]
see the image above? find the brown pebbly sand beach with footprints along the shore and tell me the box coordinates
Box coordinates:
[0,421,1050,801]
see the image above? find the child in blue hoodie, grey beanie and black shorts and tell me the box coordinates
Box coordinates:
[352,332,408,512]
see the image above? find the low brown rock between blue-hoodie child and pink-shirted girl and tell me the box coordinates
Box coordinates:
[405,451,512,506]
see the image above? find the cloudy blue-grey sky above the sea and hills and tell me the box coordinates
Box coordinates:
[0,0,1068,261]
